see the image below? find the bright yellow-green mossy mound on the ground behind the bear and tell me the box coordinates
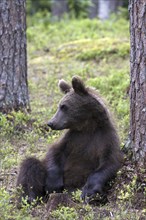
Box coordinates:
[50,37,130,61]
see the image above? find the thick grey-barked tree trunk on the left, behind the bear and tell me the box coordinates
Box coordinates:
[0,0,29,112]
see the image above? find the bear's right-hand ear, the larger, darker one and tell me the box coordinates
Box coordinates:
[72,76,88,95]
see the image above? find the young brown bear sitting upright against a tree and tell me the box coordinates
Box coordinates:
[17,77,122,202]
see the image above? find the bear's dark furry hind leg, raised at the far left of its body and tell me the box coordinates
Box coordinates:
[17,157,47,203]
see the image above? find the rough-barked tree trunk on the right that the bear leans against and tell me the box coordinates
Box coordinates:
[129,0,146,167]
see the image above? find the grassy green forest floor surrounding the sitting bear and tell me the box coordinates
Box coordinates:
[0,14,146,220]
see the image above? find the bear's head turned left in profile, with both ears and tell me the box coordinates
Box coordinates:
[48,76,105,130]
